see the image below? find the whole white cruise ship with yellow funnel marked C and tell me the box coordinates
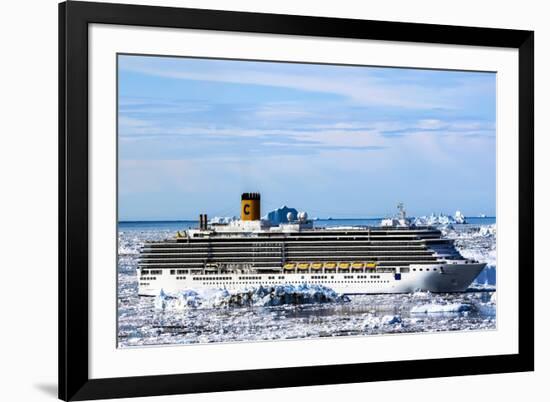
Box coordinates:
[137,193,485,296]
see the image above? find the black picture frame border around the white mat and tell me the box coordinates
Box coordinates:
[59,1,534,400]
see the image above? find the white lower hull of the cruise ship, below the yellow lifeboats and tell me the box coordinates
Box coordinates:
[137,262,485,296]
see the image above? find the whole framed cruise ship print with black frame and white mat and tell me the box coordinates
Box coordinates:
[59,1,534,400]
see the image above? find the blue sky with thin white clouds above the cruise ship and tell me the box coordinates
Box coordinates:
[118,55,496,220]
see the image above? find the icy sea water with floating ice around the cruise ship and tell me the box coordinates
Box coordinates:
[118,218,497,347]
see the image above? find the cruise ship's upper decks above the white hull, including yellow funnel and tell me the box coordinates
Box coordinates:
[139,194,466,273]
